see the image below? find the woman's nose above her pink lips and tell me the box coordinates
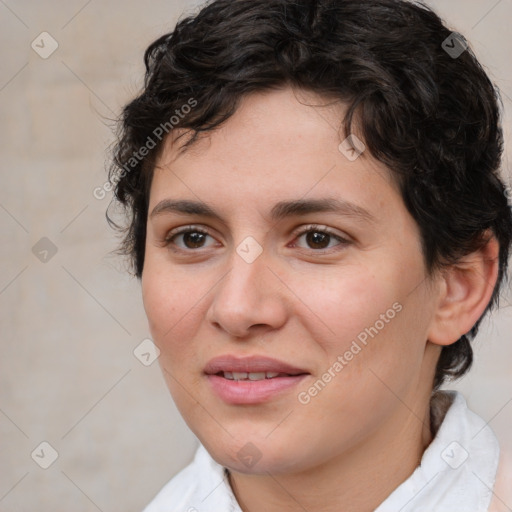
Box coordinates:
[206,248,288,339]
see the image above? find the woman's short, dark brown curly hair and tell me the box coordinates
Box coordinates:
[107,0,512,389]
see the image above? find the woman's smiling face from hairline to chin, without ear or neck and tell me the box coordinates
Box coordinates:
[142,89,442,473]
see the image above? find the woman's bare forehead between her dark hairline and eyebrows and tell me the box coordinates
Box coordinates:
[150,88,401,218]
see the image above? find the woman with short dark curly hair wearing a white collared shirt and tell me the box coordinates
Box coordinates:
[111,0,512,512]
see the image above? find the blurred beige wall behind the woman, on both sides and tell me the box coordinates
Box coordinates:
[0,0,512,512]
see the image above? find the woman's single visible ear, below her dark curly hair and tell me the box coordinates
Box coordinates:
[428,232,499,345]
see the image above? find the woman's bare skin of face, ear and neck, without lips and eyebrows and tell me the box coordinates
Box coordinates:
[142,88,497,512]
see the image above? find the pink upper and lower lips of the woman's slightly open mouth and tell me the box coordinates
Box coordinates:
[204,355,309,404]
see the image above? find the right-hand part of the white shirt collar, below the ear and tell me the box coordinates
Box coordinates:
[374,391,500,512]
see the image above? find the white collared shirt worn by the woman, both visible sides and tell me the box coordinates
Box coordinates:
[143,391,512,512]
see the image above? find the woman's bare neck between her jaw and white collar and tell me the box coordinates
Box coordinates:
[229,386,433,512]
